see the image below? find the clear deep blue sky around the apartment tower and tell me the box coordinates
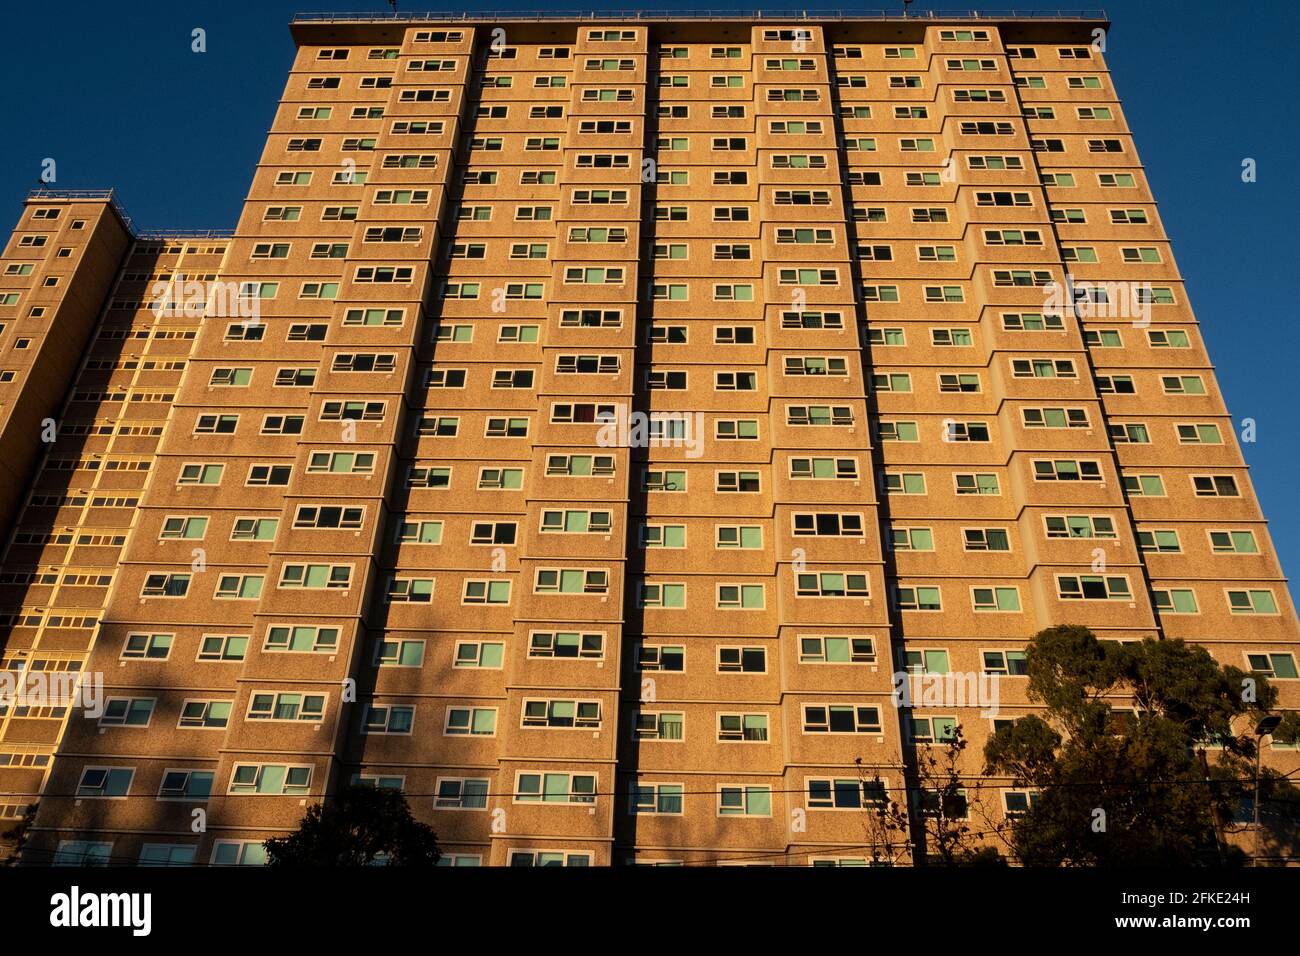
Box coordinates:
[0,0,1300,571]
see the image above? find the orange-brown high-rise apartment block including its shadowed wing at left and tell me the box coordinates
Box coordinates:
[0,17,1300,865]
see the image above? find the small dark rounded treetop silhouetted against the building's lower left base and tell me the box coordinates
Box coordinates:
[263,787,442,866]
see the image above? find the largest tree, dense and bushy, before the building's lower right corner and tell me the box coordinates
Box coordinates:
[984,626,1300,866]
